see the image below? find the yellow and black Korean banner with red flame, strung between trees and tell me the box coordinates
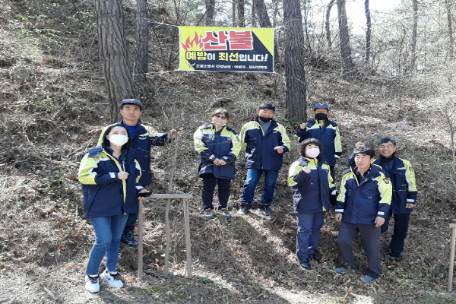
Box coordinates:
[179,26,274,73]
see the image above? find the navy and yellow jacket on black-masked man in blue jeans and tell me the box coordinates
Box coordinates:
[239,118,290,171]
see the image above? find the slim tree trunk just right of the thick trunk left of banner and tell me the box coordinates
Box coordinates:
[135,0,149,79]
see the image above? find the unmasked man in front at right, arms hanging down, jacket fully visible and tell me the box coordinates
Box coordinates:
[334,146,392,283]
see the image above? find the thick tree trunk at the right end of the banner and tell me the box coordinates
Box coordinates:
[283,0,307,124]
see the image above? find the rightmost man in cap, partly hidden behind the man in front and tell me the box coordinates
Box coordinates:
[374,137,417,261]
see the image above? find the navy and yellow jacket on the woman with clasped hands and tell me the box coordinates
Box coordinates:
[193,124,241,179]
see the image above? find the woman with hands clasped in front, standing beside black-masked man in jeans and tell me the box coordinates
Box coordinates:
[193,109,241,219]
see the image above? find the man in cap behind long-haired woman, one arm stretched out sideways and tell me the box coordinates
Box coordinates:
[97,99,175,247]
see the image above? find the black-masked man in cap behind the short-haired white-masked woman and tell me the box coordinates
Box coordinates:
[296,102,342,180]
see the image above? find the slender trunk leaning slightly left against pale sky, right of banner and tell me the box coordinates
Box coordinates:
[337,0,353,77]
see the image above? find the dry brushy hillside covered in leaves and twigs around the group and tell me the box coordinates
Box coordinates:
[0,0,456,304]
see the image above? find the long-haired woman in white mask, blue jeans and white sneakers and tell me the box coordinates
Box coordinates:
[78,125,148,292]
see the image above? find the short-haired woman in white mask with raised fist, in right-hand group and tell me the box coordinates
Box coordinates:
[288,138,336,269]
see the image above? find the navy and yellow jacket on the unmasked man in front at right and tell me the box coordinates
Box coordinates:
[335,166,392,225]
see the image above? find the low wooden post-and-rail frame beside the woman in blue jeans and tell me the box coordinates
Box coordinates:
[138,194,193,279]
